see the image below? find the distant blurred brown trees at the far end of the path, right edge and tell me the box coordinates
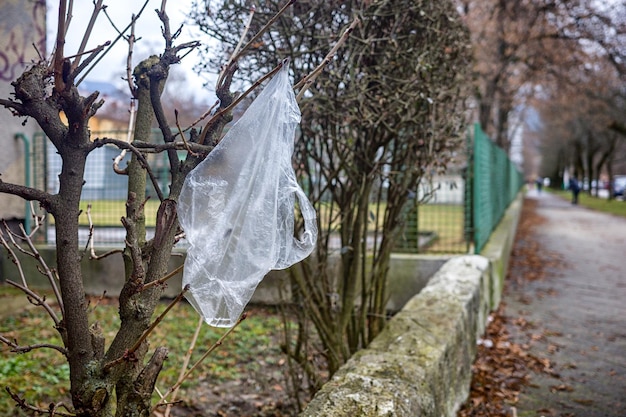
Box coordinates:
[533,61,626,193]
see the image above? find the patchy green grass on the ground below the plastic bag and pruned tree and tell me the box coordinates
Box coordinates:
[0,285,282,416]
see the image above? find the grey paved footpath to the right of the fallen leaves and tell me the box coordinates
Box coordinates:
[503,191,626,417]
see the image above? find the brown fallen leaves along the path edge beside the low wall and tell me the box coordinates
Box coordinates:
[457,199,570,417]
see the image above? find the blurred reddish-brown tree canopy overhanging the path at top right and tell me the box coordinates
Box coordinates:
[460,0,626,158]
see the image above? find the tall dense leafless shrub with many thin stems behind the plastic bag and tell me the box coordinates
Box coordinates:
[193,0,471,396]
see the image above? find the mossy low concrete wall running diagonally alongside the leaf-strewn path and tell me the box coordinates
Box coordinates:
[301,194,523,417]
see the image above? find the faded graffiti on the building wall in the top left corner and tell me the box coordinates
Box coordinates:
[0,0,46,81]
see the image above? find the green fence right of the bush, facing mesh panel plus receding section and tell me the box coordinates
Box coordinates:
[400,124,523,254]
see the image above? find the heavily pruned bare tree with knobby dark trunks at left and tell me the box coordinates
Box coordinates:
[0,0,316,417]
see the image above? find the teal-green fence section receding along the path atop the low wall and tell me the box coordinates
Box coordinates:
[468,123,524,253]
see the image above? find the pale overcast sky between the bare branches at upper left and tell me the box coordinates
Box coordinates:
[47,0,214,96]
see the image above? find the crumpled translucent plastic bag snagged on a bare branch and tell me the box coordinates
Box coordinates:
[178,64,317,327]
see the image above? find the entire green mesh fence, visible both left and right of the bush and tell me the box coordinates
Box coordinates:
[15,125,522,254]
